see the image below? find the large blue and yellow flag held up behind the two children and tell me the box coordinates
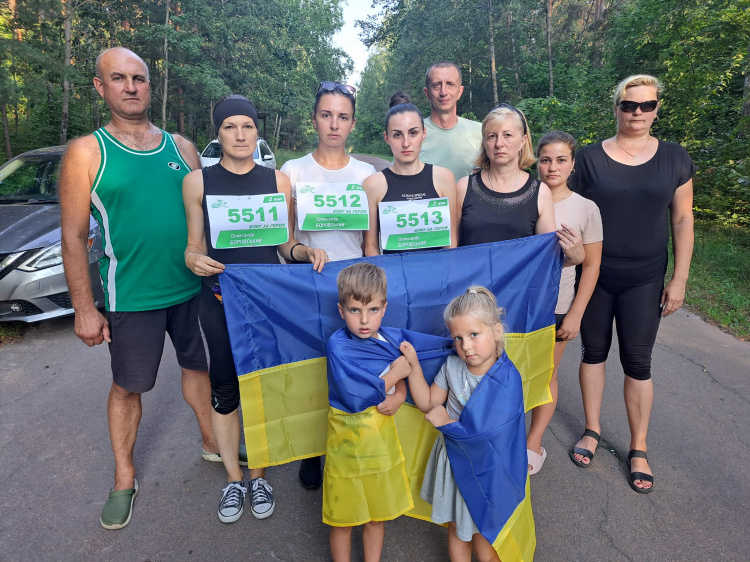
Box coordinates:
[221,233,562,560]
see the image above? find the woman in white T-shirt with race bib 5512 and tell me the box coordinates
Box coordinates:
[281,82,382,490]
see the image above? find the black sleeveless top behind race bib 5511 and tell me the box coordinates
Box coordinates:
[202,164,279,288]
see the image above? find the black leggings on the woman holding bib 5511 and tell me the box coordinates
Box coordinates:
[199,287,240,415]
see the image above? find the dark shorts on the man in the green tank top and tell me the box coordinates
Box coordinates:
[107,296,208,393]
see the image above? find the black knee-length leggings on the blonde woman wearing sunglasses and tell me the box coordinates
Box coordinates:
[581,278,664,381]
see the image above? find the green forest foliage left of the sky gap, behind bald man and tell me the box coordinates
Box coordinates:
[0,0,351,154]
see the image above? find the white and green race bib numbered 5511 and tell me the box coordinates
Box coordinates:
[206,193,289,249]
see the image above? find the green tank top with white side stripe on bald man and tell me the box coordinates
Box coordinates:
[91,128,200,312]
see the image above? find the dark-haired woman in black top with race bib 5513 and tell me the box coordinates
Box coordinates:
[362,92,458,256]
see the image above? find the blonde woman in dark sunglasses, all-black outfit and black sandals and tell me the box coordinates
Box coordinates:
[570,75,696,494]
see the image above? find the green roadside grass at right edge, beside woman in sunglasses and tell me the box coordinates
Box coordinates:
[680,224,750,340]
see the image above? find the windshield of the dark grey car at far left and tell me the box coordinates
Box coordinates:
[0,154,61,204]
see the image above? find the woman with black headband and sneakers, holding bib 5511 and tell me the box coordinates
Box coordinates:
[182,95,328,523]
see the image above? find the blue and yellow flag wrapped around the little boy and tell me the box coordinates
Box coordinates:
[323,326,454,527]
